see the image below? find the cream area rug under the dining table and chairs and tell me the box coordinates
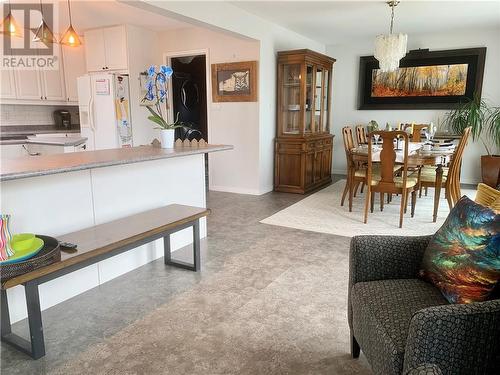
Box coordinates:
[261,180,476,237]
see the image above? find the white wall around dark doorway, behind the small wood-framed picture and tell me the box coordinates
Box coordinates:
[159,27,259,194]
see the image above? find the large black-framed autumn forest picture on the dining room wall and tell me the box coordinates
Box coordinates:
[358,47,486,109]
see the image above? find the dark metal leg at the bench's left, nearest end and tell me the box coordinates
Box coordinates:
[1,281,45,359]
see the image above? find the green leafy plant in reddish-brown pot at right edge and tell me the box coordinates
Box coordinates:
[445,95,500,188]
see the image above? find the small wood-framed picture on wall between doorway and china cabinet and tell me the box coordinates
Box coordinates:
[212,61,257,102]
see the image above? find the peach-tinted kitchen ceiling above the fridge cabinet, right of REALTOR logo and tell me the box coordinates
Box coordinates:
[49,0,191,34]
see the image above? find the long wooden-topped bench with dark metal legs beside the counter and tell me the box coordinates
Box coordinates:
[1,204,210,359]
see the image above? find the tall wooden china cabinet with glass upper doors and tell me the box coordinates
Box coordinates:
[274,49,335,194]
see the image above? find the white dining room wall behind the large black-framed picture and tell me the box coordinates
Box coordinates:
[327,29,500,183]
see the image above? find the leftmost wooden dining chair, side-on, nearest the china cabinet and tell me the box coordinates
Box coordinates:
[340,126,366,212]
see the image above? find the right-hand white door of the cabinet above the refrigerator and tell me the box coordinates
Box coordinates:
[103,26,128,70]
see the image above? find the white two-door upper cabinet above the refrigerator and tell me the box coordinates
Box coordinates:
[85,25,128,72]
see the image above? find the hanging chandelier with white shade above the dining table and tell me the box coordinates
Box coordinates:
[374,1,408,72]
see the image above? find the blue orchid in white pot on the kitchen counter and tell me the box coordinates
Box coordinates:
[142,65,189,148]
